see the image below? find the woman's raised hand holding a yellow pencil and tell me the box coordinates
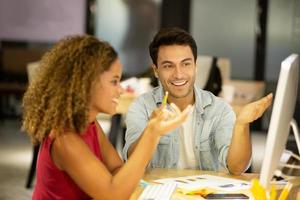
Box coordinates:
[148,103,191,136]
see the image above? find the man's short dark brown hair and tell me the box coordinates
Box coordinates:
[149,27,197,66]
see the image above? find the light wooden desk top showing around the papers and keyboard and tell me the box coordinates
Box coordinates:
[130,168,300,200]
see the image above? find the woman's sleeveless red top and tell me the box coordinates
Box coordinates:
[32,123,103,200]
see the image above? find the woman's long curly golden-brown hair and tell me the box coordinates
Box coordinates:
[22,35,117,144]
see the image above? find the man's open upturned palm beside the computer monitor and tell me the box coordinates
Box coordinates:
[236,93,273,125]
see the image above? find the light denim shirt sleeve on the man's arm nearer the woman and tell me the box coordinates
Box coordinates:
[122,96,149,160]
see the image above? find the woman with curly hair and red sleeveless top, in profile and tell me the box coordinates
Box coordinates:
[23,35,189,200]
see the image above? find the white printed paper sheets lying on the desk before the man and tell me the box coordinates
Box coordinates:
[154,174,251,192]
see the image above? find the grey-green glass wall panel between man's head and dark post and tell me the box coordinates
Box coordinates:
[190,0,256,79]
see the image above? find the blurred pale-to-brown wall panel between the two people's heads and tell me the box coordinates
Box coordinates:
[95,0,161,76]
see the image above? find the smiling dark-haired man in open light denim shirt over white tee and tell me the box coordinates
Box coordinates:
[123,28,272,174]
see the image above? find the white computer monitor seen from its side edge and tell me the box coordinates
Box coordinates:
[260,54,299,188]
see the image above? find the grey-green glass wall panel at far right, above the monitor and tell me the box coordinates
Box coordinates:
[266,0,300,98]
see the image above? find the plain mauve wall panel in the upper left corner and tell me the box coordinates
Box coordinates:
[0,0,86,42]
